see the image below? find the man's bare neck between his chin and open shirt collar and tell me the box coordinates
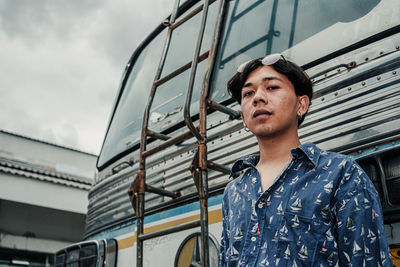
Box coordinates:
[257,131,300,165]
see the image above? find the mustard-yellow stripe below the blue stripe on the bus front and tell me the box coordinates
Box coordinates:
[118,209,222,250]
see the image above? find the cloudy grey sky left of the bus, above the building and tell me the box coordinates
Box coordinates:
[0,0,174,154]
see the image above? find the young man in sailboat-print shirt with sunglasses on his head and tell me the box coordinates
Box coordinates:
[220,54,392,267]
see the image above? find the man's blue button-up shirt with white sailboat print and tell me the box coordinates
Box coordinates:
[220,143,393,267]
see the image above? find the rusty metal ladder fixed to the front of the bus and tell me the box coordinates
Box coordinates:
[128,0,240,267]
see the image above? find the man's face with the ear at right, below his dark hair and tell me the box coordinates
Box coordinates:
[241,66,309,138]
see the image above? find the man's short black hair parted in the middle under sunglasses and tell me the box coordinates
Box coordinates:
[227,58,313,126]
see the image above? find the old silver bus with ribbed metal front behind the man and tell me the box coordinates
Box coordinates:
[55,0,400,267]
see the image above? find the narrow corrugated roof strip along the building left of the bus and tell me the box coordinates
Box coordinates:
[0,157,93,190]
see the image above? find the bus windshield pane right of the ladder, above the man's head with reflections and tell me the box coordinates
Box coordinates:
[211,0,400,102]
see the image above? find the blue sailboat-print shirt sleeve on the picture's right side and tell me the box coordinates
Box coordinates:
[333,162,393,267]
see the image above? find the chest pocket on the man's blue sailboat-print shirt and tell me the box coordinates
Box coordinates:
[277,211,320,267]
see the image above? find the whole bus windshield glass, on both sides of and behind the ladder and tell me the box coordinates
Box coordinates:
[98,0,400,172]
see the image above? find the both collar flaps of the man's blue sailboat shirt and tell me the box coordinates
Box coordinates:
[230,143,322,177]
